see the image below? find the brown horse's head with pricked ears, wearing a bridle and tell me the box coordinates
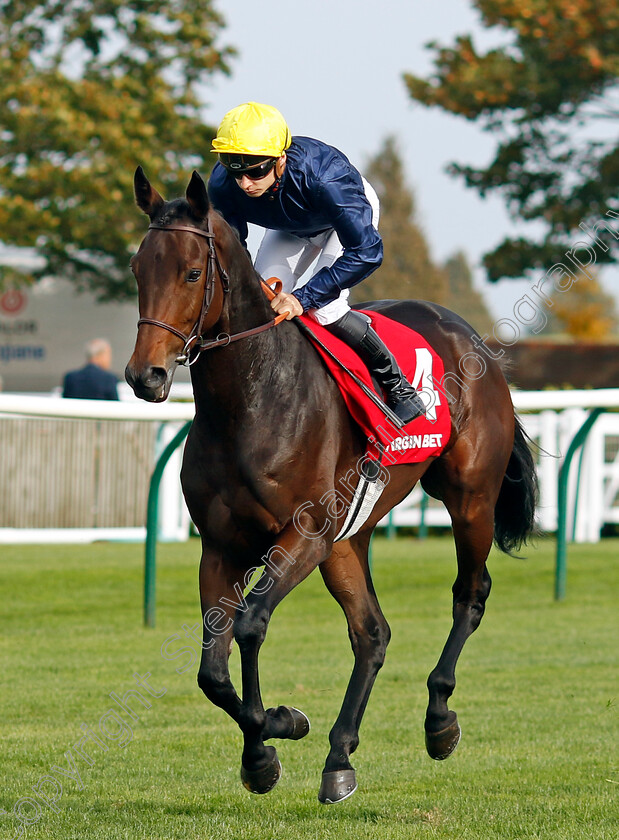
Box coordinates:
[125,167,224,402]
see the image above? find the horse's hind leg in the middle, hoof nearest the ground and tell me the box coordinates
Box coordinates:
[318,534,390,804]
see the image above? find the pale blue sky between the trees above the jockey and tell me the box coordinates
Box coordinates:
[204,0,540,318]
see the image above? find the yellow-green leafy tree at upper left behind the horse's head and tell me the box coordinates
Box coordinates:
[0,0,232,299]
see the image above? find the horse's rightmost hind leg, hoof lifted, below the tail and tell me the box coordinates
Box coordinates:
[425,501,494,759]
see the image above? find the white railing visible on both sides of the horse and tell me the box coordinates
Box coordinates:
[0,386,619,542]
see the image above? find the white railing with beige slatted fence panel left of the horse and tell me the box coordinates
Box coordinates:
[0,387,194,543]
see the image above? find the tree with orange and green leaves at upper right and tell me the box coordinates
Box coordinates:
[404,0,619,280]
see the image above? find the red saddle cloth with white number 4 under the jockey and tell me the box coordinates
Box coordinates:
[300,311,451,465]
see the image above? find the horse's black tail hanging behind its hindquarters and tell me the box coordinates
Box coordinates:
[494,415,538,554]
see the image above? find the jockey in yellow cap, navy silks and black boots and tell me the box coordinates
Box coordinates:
[208,102,424,424]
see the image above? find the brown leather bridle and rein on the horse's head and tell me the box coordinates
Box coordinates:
[138,217,282,367]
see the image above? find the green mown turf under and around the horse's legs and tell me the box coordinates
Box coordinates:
[0,538,619,840]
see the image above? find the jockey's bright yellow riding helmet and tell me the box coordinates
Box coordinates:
[211,102,292,157]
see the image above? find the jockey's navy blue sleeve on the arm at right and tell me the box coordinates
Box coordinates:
[294,175,383,311]
